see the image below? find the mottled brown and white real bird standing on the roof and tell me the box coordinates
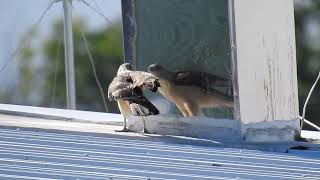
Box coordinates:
[108,63,160,133]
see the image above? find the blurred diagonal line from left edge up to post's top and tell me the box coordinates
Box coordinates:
[0,0,57,73]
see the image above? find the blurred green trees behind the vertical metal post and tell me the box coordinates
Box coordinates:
[20,19,123,112]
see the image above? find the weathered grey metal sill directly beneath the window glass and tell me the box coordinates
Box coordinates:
[128,114,241,143]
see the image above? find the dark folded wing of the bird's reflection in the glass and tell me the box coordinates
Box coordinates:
[173,71,230,88]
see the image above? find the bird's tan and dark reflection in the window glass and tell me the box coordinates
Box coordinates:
[148,64,234,117]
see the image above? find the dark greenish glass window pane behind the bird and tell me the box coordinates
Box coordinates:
[124,0,233,119]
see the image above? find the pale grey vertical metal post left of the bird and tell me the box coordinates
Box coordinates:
[63,0,76,109]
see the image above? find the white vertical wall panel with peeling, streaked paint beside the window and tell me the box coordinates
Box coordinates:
[231,0,299,141]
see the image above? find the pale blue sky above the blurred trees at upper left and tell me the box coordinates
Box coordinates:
[0,0,121,85]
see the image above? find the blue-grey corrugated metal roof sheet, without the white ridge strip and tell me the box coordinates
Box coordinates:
[0,127,320,180]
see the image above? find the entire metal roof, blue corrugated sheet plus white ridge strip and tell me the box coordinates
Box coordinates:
[0,104,320,180]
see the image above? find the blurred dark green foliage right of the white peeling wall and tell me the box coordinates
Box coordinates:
[295,0,320,129]
